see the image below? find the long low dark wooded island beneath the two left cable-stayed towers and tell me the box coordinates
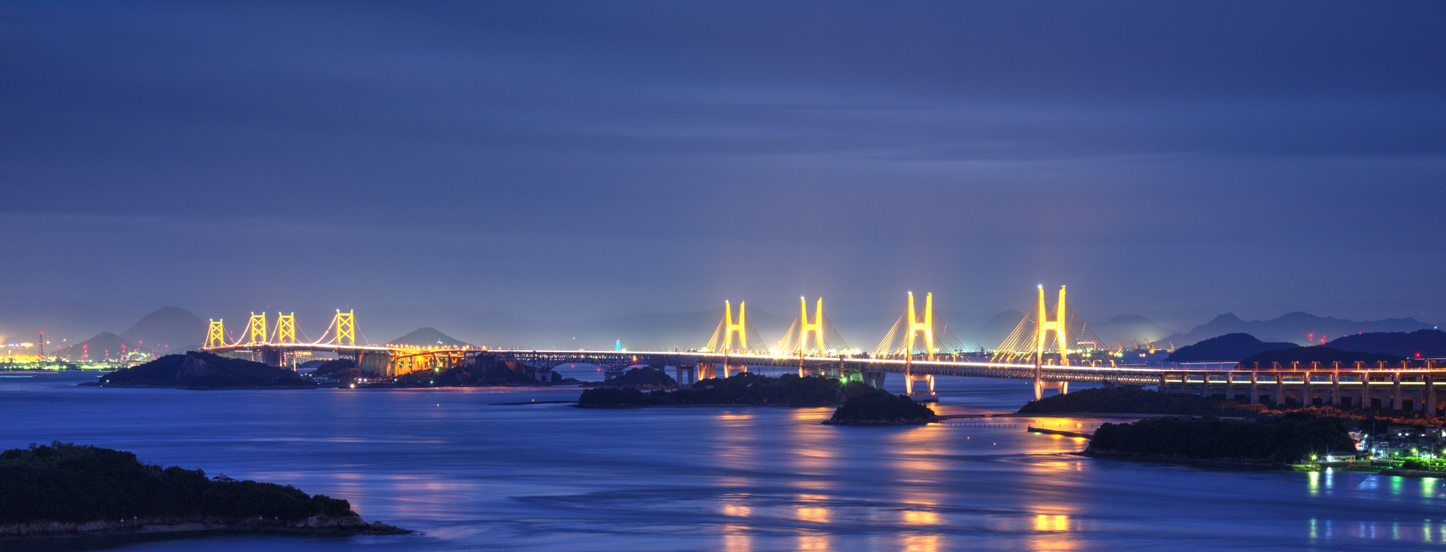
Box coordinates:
[577,370,884,407]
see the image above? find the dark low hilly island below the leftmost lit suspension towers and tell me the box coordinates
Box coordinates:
[100,351,315,389]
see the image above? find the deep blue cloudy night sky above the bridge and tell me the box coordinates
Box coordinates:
[0,1,1446,332]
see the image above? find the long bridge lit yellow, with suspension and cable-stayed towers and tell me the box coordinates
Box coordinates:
[204,285,1446,409]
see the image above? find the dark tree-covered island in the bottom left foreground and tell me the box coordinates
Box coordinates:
[0,442,411,539]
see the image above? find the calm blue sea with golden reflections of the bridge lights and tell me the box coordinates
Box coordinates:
[0,374,1446,551]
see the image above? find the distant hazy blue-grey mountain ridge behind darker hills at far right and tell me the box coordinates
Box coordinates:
[1168,312,1432,347]
